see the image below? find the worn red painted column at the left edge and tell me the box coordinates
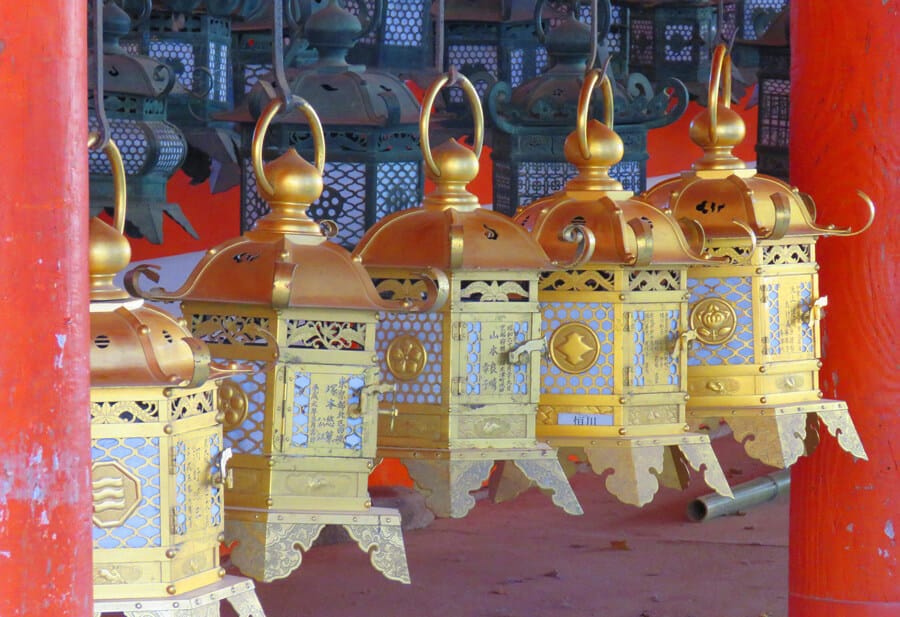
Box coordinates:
[0,0,93,617]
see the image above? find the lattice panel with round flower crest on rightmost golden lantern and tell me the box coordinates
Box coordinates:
[688,277,755,366]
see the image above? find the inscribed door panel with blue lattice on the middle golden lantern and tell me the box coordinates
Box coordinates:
[460,320,530,397]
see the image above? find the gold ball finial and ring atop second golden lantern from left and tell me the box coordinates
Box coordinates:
[250,96,325,239]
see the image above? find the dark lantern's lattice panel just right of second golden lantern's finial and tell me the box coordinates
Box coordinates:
[309,162,366,247]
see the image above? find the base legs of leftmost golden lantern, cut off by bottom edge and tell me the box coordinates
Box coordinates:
[93,576,265,617]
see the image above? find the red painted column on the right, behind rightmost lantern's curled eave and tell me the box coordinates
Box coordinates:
[789,0,900,617]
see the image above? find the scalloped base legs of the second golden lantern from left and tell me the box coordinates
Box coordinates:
[225,508,410,584]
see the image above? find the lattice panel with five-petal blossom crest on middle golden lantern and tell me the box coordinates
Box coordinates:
[375,313,444,405]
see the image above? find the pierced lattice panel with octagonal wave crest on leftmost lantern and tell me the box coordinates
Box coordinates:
[91,437,162,549]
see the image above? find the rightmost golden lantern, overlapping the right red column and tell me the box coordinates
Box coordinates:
[645,46,875,467]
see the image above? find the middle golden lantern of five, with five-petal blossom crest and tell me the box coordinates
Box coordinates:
[353,75,582,517]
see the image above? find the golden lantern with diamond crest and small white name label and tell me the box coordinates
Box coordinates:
[516,70,731,506]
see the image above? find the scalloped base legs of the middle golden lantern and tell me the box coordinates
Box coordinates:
[394,445,584,518]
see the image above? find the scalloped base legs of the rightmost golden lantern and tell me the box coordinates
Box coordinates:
[688,399,867,469]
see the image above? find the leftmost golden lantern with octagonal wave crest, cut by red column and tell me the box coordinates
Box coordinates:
[88,134,262,617]
